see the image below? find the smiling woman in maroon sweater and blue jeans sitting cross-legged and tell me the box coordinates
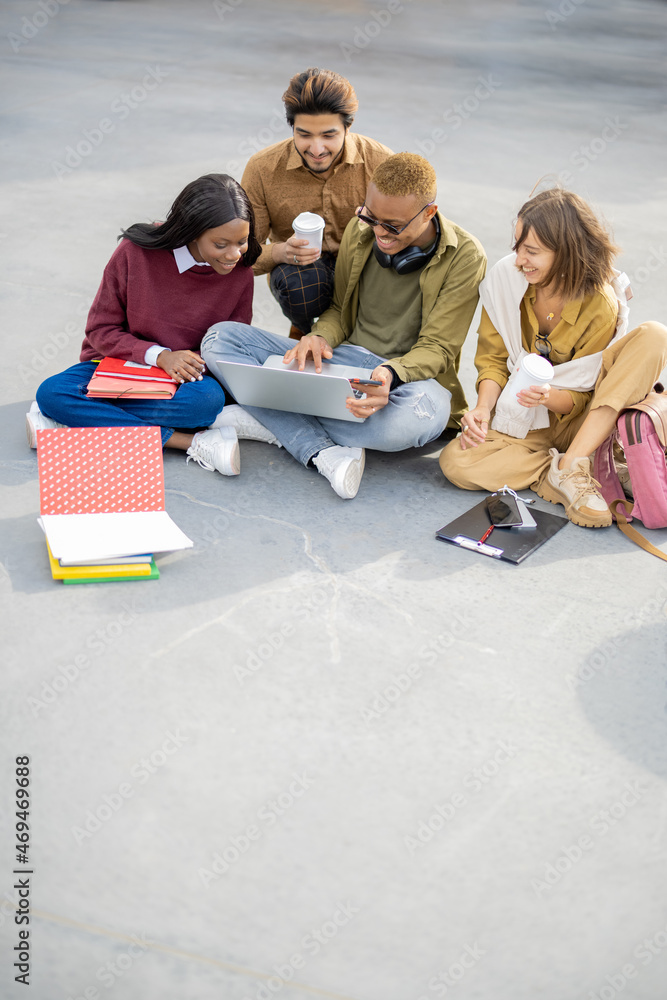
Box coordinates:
[27,174,260,475]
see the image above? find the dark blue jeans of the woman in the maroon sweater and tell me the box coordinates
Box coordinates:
[36,361,225,447]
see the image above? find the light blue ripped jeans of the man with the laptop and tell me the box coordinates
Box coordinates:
[201,322,451,465]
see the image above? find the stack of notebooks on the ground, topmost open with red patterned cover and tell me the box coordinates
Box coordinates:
[37,427,192,584]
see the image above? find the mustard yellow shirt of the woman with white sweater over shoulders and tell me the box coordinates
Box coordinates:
[475,285,618,421]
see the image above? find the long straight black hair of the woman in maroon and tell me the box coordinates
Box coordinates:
[118,174,262,267]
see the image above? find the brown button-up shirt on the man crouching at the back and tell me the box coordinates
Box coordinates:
[241,132,391,274]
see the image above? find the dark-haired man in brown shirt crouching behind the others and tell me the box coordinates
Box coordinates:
[241,69,391,338]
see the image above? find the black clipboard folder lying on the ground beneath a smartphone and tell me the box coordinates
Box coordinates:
[435,500,568,565]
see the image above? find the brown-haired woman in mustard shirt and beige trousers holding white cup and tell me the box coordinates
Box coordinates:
[440,188,667,528]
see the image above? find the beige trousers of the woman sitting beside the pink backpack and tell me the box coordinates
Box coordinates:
[440,322,667,490]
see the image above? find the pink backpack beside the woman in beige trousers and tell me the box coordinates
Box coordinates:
[593,383,667,560]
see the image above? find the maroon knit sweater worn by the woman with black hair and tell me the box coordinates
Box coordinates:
[79,239,253,362]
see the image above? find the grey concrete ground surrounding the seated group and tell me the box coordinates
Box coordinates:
[0,0,667,1000]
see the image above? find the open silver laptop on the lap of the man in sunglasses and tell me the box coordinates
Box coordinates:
[215,354,380,423]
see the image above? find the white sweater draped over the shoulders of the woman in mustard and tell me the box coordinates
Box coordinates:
[479,253,630,438]
